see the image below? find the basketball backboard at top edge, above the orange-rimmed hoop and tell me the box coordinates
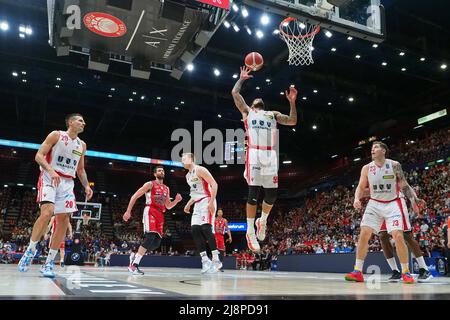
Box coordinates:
[243,0,386,42]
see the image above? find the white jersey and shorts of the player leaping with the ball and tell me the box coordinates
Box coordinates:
[244,109,278,188]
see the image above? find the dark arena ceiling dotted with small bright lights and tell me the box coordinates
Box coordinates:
[0,0,450,170]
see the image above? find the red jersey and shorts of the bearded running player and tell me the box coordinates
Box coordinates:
[142,180,170,238]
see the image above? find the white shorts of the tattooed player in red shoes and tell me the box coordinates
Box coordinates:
[361,198,409,233]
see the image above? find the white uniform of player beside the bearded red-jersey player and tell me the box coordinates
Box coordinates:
[186,165,217,229]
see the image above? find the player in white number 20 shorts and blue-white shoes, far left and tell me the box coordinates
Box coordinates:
[18,113,93,278]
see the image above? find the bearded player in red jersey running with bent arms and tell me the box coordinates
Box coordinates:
[123,166,182,275]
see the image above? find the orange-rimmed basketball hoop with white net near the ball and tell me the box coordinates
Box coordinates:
[279,17,320,66]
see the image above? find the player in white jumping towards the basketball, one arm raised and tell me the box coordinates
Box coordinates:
[231,67,297,252]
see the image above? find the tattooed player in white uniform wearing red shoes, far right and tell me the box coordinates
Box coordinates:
[345,141,423,283]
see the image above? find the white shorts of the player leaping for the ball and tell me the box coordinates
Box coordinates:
[244,148,278,188]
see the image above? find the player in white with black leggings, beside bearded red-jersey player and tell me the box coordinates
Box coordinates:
[181,153,222,273]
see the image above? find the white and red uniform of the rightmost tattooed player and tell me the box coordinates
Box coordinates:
[361,159,411,233]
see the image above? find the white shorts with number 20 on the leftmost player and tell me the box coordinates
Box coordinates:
[36,171,78,215]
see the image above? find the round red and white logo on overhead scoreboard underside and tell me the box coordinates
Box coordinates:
[83,12,127,38]
